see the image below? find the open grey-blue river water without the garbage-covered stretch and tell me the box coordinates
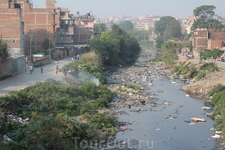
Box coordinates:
[107,54,220,150]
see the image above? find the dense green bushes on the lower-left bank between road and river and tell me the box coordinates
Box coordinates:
[0,80,117,150]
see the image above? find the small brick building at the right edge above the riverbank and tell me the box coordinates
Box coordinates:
[192,27,225,54]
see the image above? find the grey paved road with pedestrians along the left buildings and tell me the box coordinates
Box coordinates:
[0,57,71,96]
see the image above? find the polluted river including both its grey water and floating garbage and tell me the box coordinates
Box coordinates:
[101,53,220,150]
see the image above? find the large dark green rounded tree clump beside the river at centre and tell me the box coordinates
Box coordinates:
[90,25,141,66]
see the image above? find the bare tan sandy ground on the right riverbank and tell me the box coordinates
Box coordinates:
[178,54,225,99]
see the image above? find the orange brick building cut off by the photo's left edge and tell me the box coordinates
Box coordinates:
[0,0,24,54]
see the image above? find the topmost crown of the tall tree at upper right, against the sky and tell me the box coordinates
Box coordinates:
[193,5,216,20]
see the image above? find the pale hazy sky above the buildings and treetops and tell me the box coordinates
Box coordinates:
[32,0,225,18]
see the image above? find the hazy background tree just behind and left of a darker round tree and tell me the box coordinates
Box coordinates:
[155,16,176,36]
